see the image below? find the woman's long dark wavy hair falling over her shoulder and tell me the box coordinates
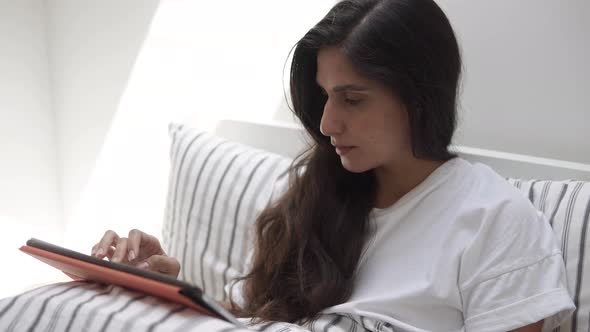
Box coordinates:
[232,0,461,322]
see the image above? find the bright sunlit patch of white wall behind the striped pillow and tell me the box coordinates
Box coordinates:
[66,0,334,251]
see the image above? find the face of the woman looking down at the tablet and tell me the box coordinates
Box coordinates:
[316,47,414,173]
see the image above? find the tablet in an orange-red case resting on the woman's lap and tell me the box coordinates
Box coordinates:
[20,238,244,327]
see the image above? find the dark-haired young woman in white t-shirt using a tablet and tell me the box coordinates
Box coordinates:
[93,0,574,331]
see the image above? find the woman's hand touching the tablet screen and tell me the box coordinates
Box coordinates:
[92,229,180,278]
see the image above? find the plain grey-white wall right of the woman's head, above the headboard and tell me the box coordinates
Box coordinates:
[438,0,590,164]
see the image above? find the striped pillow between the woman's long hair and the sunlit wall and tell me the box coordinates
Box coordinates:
[162,124,291,301]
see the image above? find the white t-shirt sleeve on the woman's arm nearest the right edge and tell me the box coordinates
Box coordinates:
[459,202,575,332]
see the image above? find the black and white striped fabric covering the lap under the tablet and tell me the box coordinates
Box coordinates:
[0,282,388,332]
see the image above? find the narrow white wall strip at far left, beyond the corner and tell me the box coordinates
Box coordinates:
[0,0,63,297]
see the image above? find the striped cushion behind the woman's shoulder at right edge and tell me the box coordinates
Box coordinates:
[508,179,590,332]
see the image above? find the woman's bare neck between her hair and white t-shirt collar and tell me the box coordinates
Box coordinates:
[375,158,444,209]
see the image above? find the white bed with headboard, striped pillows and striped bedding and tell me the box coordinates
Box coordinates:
[0,120,590,332]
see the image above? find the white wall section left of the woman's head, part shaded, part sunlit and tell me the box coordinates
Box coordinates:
[48,0,333,250]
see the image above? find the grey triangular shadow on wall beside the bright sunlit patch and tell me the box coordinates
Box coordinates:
[47,0,160,233]
